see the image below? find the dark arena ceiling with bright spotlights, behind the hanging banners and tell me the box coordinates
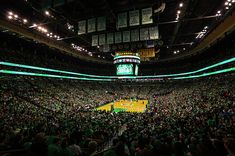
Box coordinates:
[0,0,235,61]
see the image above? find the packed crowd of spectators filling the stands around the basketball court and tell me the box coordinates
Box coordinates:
[0,77,235,156]
